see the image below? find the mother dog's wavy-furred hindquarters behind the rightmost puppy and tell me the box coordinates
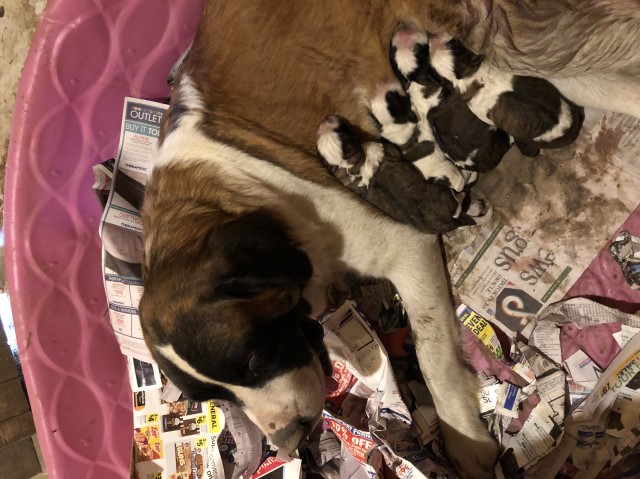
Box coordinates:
[420,0,640,118]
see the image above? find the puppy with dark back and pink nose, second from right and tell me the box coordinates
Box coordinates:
[389,23,510,173]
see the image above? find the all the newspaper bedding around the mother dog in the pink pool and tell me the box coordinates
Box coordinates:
[94,99,640,479]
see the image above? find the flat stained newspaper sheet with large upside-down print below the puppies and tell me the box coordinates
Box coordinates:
[445,111,640,337]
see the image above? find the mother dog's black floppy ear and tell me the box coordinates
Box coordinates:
[208,210,313,298]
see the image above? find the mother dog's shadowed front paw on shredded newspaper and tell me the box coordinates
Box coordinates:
[440,421,500,479]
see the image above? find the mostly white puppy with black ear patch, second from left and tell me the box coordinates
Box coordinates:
[370,82,466,191]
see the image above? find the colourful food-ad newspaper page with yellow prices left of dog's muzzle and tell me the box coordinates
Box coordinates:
[133,389,263,479]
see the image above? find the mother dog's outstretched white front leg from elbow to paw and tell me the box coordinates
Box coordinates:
[382,236,498,479]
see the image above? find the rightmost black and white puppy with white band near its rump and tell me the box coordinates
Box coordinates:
[429,34,584,156]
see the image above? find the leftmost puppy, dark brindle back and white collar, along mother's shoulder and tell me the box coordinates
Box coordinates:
[318,116,492,233]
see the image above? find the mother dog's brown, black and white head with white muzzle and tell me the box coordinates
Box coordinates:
[140,211,331,452]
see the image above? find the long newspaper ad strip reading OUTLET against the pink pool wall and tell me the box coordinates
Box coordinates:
[94,98,167,362]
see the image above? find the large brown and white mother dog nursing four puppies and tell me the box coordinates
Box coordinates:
[141,0,640,478]
